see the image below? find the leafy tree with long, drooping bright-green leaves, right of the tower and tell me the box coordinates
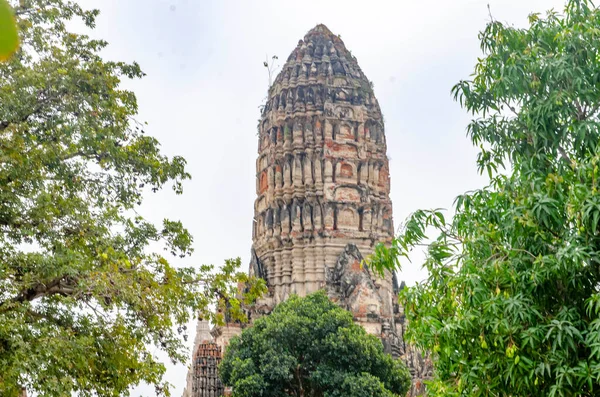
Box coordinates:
[372,0,600,396]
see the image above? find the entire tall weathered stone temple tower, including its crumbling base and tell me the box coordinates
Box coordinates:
[184,25,431,397]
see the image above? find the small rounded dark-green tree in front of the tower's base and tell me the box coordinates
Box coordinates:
[220,291,410,397]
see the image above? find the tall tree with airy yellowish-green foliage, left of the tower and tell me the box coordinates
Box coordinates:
[0,0,264,396]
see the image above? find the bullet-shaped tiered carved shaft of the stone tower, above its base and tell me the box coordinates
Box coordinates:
[251,25,393,304]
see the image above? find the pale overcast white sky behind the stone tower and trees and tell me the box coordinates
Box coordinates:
[72,0,564,396]
